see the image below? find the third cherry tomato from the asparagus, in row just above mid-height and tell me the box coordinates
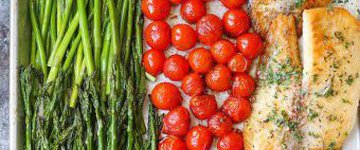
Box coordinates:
[188,48,214,73]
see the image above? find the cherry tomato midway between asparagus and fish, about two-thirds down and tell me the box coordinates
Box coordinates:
[190,95,217,120]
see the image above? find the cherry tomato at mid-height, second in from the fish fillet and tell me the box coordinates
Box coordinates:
[205,64,231,92]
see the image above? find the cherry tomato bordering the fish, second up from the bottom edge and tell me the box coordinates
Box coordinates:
[222,96,251,123]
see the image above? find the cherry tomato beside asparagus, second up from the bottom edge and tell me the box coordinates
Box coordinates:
[162,106,190,137]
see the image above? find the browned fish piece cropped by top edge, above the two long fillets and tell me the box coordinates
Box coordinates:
[249,0,331,38]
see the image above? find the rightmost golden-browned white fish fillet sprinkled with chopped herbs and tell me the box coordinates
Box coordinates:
[302,8,360,149]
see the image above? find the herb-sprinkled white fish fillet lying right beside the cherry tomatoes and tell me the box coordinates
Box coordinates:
[244,15,302,150]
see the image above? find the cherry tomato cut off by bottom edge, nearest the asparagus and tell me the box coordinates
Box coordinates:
[158,135,186,150]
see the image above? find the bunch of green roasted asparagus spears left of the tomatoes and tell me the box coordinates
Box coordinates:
[20,0,160,150]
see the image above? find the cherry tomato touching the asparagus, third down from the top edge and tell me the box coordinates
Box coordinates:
[142,49,166,76]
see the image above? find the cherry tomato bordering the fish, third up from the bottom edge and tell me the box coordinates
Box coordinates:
[231,74,255,97]
